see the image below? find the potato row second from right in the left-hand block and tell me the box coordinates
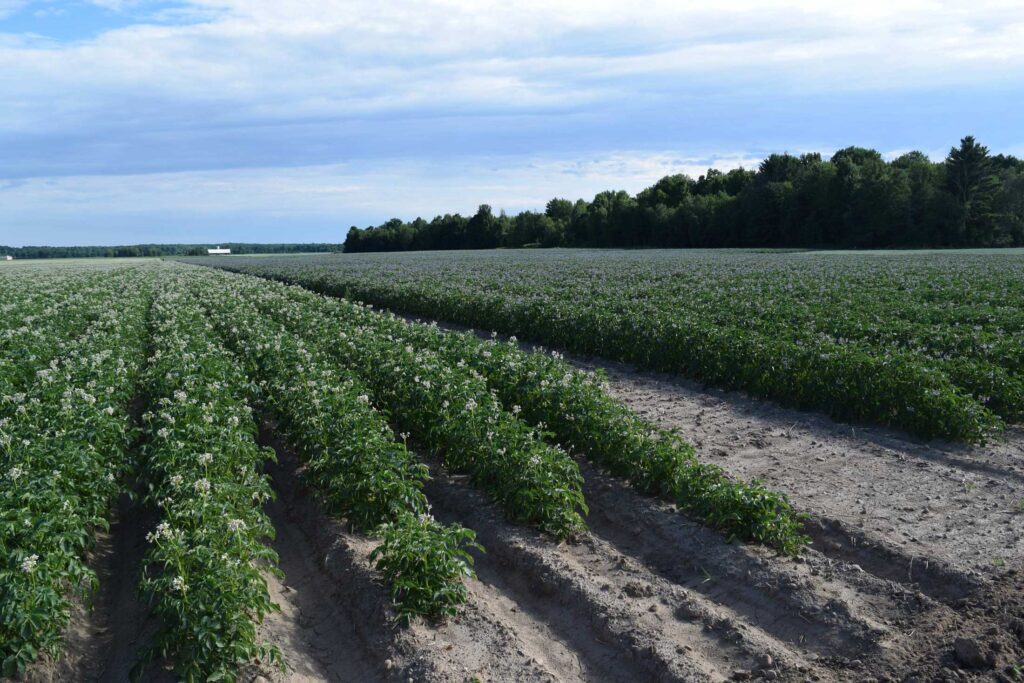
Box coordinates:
[192,266,587,538]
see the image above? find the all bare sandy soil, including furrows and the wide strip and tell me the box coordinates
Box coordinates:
[19,342,1024,682]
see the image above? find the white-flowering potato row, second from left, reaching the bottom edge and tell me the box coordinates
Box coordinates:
[135,272,282,681]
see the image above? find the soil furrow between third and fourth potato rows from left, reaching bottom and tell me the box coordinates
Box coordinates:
[426,468,768,681]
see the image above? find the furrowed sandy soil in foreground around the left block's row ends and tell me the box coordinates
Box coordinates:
[243,411,1024,681]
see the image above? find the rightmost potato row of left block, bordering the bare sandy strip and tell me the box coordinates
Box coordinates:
[247,278,808,553]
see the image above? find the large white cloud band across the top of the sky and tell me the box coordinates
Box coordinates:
[0,0,1024,136]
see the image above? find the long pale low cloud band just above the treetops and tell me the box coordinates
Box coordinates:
[0,152,760,230]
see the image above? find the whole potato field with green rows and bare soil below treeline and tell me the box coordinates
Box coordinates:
[0,250,1024,683]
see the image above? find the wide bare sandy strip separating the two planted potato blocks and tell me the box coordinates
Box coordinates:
[578,361,1024,595]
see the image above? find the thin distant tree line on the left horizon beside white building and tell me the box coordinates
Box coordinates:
[0,242,342,259]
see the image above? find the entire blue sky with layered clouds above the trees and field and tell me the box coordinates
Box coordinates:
[0,0,1024,246]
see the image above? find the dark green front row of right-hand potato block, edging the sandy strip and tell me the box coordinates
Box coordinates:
[343,278,1002,442]
